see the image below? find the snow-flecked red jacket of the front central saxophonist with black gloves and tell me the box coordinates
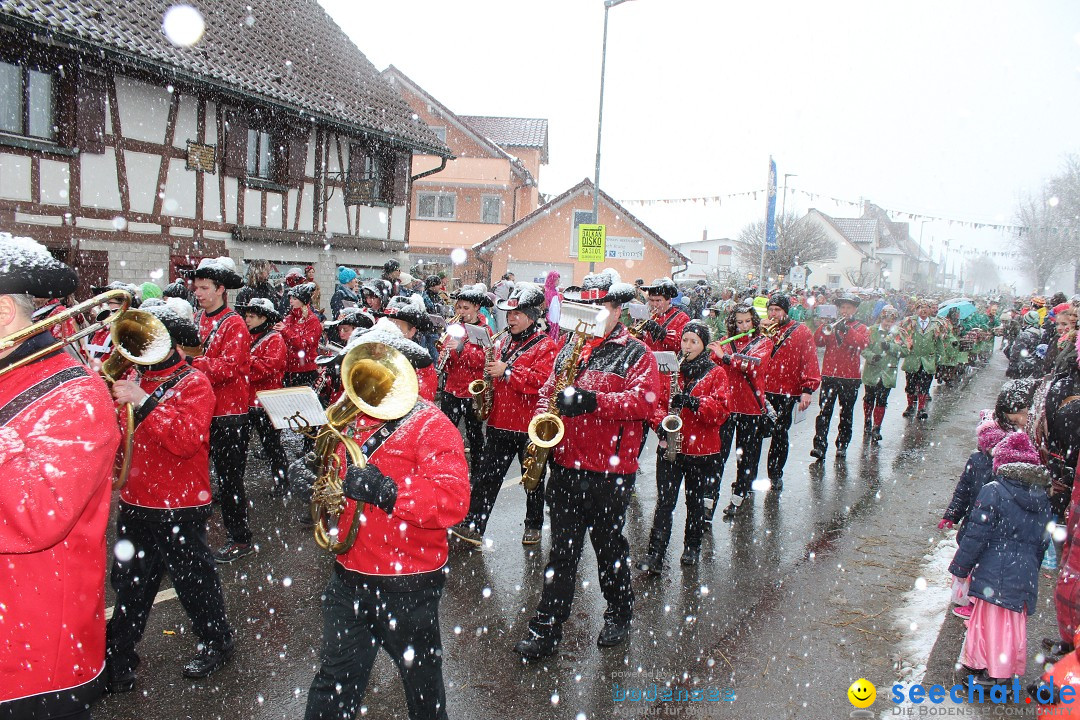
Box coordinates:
[537,324,660,475]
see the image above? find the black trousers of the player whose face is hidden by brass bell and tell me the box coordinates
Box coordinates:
[303,565,446,720]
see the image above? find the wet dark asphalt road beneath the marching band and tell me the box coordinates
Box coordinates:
[94,358,1000,720]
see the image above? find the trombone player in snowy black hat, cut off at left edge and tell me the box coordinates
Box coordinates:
[0,233,120,720]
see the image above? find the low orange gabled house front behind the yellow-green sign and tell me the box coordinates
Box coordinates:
[472,178,689,287]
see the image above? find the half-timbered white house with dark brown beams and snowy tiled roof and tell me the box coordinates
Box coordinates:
[0,0,450,297]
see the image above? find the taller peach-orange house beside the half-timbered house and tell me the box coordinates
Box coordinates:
[382,65,548,283]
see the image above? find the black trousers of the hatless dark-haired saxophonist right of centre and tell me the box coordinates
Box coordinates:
[649,449,720,557]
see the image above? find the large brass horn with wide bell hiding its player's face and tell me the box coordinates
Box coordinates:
[311,342,420,555]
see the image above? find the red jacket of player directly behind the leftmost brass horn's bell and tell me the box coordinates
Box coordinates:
[191,308,252,418]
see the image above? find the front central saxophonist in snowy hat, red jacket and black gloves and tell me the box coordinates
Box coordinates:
[515,270,660,658]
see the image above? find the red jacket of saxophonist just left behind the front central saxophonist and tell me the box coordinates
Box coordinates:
[487,330,557,433]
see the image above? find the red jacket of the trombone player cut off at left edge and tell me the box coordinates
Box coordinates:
[0,349,120,717]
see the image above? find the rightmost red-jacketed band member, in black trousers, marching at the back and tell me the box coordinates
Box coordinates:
[810,295,870,460]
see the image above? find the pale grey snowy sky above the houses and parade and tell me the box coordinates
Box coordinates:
[320,0,1080,287]
